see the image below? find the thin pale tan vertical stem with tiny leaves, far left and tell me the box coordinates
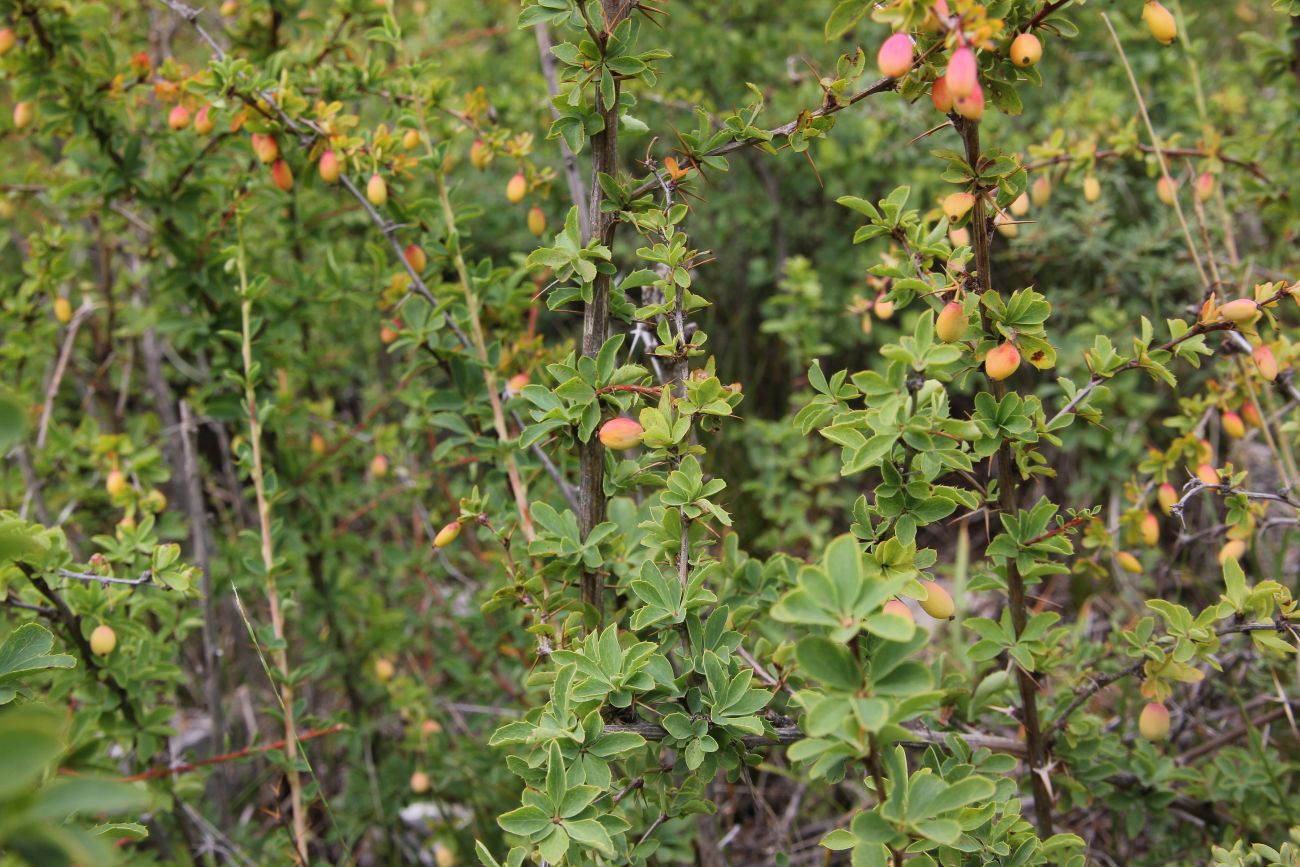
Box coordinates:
[235,213,307,863]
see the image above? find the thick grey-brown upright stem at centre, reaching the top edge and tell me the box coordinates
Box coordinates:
[577,0,620,612]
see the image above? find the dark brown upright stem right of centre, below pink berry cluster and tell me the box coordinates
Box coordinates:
[961,121,1052,837]
